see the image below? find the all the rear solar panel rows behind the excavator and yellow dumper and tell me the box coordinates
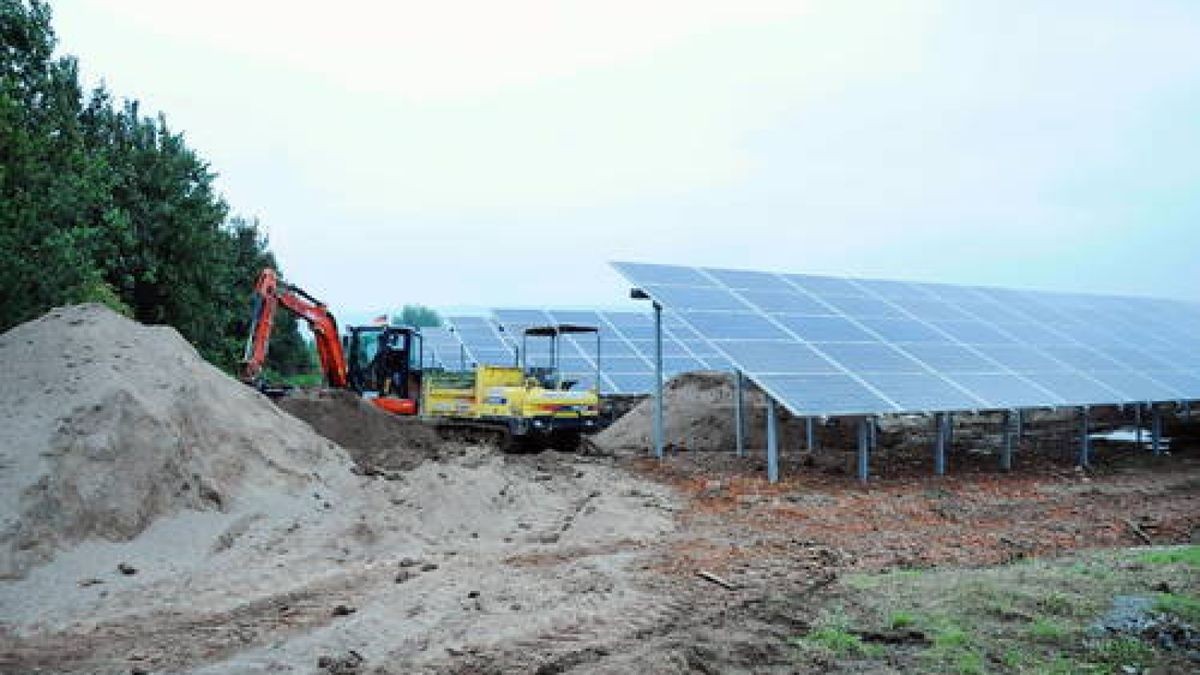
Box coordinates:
[422,309,728,394]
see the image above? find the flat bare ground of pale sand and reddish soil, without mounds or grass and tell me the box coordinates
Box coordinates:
[0,432,1200,674]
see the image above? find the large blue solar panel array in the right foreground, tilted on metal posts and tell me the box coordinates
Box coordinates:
[613,258,1200,416]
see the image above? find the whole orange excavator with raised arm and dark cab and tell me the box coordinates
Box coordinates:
[242,268,421,414]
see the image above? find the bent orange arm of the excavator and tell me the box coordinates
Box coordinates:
[242,268,349,389]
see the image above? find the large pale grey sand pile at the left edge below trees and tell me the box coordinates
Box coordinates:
[0,305,349,578]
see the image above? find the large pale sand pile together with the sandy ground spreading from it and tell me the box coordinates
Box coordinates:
[0,306,678,674]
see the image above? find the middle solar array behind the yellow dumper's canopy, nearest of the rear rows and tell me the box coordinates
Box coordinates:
[492,307,728,394]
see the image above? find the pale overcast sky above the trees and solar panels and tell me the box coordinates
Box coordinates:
[52,0,1200,313]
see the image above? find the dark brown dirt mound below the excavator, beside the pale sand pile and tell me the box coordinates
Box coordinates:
[278,389,440,471]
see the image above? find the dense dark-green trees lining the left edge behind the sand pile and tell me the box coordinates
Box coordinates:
[0,0,310,372]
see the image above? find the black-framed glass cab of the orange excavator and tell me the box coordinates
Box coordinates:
[342,325,422,414]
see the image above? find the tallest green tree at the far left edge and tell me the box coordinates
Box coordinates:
[0,0,124,319]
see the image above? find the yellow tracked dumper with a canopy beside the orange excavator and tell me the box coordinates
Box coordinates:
[421,324,609,452]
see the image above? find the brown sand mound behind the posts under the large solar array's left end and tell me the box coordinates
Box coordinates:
[592,372,820,452]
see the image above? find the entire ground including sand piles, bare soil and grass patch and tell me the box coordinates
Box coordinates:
[0,317,1200,674]
